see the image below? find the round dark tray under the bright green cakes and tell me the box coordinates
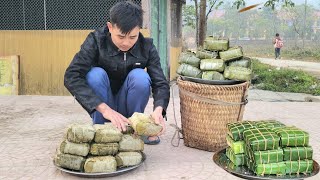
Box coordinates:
[213,149,319,180]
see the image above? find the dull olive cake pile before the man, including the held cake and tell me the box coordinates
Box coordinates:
[54,113,162,173]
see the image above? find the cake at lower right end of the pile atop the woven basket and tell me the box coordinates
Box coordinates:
[223,66,252,81]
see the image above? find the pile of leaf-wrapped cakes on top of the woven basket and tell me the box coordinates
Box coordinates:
[177,37,252,81]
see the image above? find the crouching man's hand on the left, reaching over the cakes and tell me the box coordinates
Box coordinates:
[96,103,130,131]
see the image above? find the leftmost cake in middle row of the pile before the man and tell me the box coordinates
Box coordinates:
[60,140,90,156]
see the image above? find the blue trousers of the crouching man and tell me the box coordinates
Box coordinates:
[86,67,151,124]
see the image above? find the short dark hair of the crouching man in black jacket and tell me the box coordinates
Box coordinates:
[110,1,143,34]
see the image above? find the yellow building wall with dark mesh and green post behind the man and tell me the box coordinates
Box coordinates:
[0,0,185,95]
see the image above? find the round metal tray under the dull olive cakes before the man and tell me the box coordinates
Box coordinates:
[53,153,146,178]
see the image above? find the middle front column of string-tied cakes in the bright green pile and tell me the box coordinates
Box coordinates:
[243,121,286,175]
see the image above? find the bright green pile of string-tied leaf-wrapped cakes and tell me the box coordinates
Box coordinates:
[226,120,313,176]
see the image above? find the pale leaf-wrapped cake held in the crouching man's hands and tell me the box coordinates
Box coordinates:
[129,112,162,136]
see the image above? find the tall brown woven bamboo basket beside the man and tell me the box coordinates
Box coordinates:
[177,77,248,151]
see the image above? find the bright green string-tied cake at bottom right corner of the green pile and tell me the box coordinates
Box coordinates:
[285,159,313,174]
